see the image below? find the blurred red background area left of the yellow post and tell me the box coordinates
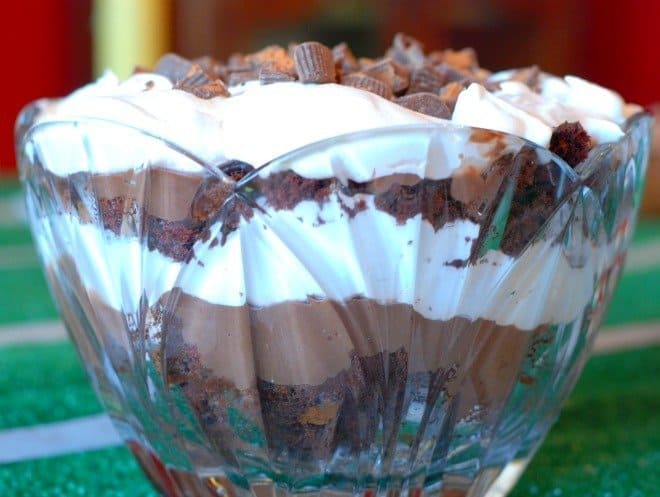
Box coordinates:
[0,0,91,174]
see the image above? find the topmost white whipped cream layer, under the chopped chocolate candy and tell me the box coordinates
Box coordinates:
[37,69,639,181]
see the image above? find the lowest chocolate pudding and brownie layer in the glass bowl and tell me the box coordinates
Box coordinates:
[166,294,546,459]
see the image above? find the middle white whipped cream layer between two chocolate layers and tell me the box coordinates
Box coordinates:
[37,190,611,330]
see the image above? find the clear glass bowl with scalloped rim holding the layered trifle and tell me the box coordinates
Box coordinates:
[18,105,651,497]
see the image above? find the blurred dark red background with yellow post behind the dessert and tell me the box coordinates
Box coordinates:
[0,0,660,198]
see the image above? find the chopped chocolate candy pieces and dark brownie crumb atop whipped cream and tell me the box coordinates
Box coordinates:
[146,33,612,149]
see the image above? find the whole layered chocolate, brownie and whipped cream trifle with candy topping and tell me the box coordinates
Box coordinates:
[17,35,643,495]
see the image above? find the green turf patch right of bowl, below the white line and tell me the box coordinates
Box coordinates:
[511,347,660,497]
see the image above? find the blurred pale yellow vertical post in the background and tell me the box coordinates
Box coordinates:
[92,0,171,78]
